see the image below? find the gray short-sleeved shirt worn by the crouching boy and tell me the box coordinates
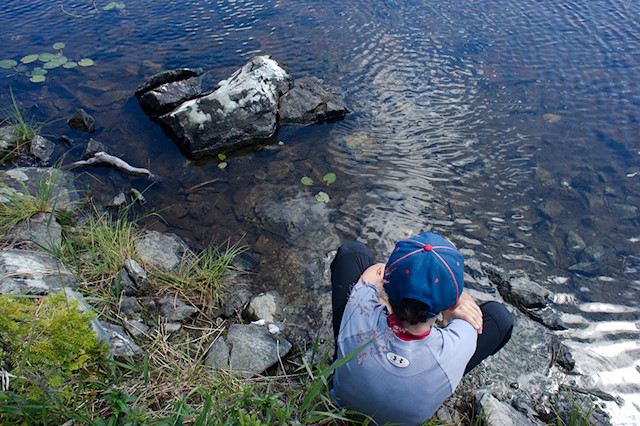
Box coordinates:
[333,283,477,424]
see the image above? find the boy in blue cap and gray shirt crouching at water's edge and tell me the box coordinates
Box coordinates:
[331,232,513,424]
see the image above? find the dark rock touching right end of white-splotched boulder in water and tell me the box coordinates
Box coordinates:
[278,77,348,124]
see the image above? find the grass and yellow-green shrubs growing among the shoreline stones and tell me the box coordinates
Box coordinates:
[0,93,604,425]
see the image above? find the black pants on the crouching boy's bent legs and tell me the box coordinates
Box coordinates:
[331,241,513,374]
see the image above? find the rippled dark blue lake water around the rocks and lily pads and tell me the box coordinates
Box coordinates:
[0,0,640,422]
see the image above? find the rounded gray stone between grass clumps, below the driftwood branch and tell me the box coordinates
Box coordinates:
[134,231,193,272]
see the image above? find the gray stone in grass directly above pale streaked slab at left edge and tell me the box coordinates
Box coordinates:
[1,213,62,251]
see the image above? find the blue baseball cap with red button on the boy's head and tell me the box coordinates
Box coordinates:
[384,232,464,316]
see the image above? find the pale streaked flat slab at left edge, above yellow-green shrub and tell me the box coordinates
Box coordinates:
[0,249,77,295]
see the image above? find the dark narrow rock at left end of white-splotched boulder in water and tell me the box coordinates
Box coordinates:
[138,77,202,117]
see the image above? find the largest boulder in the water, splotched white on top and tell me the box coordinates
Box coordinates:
[158,56,291,157]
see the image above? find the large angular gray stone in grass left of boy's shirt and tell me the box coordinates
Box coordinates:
[227,324,291,378]
